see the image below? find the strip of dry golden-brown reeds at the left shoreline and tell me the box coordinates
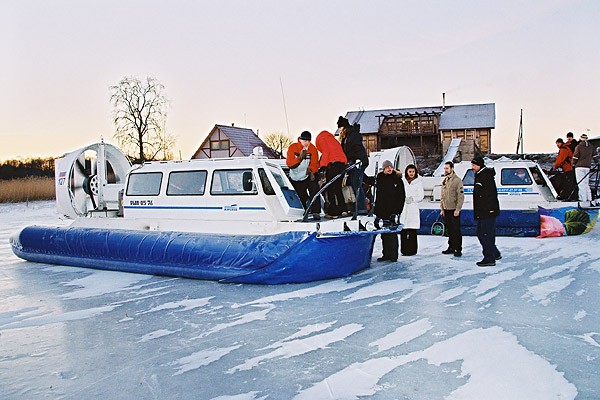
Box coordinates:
[0,177,55,203]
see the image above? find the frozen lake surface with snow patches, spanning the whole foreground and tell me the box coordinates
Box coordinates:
[0,202,600,400]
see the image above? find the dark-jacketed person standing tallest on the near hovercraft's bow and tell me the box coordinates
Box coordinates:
[337,116,369,215]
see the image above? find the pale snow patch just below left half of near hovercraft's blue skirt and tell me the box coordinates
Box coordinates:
[61,271,152,299]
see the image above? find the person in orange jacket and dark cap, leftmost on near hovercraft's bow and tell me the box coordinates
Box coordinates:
[285,131,321,220]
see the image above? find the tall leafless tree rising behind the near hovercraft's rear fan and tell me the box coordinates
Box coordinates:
[110,77,175,162]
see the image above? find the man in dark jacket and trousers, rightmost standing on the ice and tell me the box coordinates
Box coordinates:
[471,157,502,267]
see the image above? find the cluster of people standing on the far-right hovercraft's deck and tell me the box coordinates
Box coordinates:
[552,132,598,206]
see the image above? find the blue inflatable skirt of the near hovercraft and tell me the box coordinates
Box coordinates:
[11,226,376,284]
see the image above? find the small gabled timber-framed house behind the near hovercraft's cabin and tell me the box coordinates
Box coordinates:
[192,124,277,159]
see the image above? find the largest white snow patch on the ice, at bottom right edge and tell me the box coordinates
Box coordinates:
[295,327,577,400]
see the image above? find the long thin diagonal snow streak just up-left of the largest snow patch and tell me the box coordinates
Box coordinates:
[227,324,364,374]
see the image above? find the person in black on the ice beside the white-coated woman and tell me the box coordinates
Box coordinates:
[375,160,405,261]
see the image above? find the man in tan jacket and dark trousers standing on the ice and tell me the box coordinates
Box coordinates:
[440,161,465,257]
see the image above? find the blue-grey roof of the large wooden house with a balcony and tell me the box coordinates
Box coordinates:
[346,103,496,134]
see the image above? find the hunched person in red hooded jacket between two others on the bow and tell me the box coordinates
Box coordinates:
[315,131,348,218]
